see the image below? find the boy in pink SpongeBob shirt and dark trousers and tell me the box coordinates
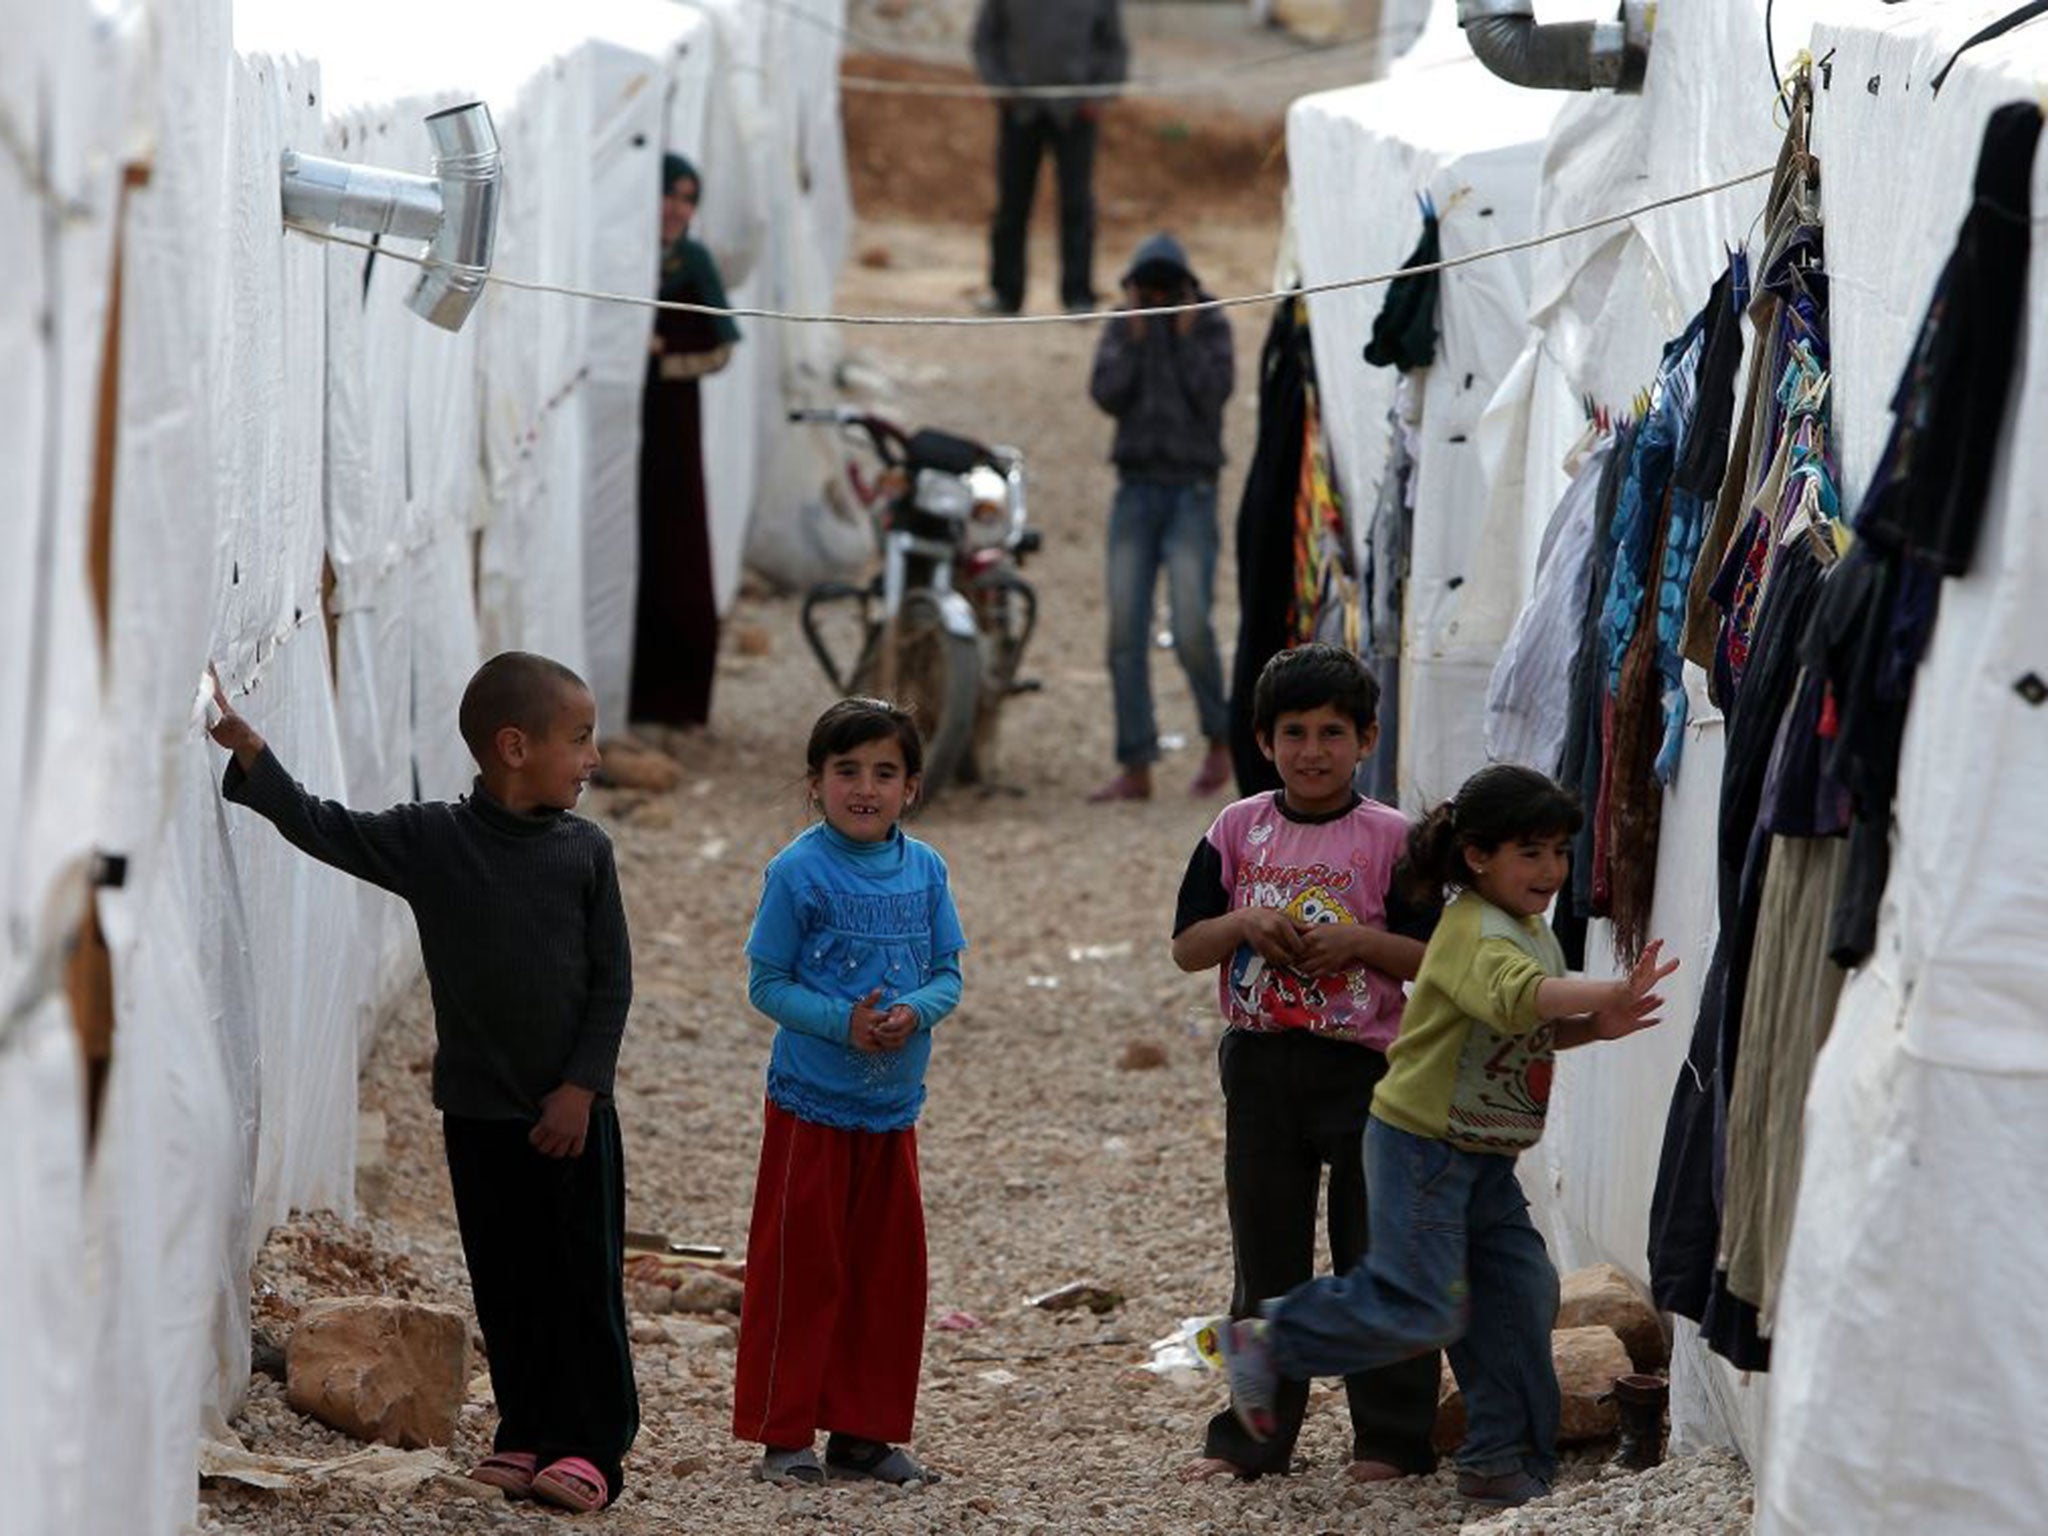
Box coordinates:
[1174,645,1440,1481]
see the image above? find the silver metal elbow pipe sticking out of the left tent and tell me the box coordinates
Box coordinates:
[283,102,504,330]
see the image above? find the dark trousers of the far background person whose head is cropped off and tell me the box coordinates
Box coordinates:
[989,106,1096,313]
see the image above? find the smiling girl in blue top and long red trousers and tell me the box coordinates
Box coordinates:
[733,698,967,1483]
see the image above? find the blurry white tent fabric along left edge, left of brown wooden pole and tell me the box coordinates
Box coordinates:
[0,0,123,1530]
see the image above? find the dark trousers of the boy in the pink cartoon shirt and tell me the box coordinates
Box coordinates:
[1202,1030,1442,1475]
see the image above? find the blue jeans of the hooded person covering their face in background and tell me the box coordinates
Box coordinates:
[1108,479,1231,768]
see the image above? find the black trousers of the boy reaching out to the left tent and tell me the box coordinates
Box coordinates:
[440,1104,639,1499]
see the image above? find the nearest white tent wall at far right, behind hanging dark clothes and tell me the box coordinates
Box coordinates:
[1757,12,2048,1536]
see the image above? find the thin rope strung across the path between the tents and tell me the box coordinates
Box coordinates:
[287,166,1776,328]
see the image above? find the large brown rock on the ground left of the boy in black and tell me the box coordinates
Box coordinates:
[285,1296,469,1450]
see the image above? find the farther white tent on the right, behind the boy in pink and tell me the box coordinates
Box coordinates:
[1288,59,1556,805]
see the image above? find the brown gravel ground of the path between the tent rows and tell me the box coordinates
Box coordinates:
[201,39,1749,1536]
